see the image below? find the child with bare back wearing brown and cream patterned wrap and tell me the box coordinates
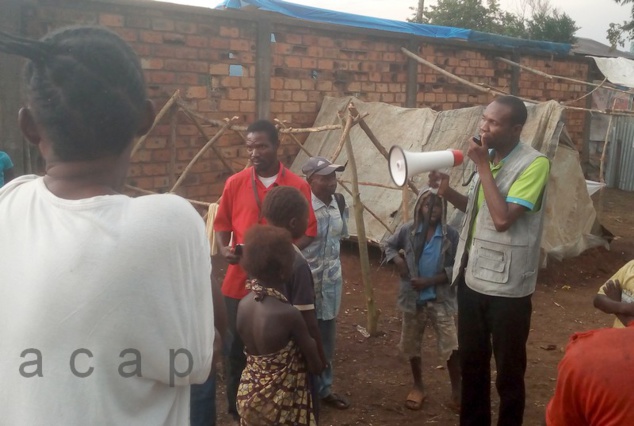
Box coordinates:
[236,225,323,426]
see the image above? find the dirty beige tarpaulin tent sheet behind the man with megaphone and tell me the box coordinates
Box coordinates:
[291,97,606,259]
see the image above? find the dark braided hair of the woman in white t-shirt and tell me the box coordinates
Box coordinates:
[0,26,147,161]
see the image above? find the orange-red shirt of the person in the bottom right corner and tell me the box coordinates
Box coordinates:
[546,322,634,426]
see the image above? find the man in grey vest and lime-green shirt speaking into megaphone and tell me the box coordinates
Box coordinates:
[429,96,550,426]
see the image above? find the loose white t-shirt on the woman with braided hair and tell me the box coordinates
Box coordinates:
[0,176,214,426]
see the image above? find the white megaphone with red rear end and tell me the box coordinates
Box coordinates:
[389,145,463,186]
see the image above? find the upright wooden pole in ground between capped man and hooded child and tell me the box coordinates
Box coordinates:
[344,105,379,336]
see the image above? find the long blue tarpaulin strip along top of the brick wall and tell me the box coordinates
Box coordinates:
[218,0,571,54]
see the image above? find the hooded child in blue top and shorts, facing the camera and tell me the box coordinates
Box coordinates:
[383,189,460,411]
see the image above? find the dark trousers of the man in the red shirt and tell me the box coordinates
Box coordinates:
[225,297,247,416]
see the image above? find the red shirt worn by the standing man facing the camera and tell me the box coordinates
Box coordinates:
[214,163,317,299]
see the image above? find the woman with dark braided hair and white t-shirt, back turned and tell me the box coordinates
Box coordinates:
[0,27,215,426]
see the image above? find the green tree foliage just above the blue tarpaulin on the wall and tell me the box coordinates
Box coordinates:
[408,0,576,43]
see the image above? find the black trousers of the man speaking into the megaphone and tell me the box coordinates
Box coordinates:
[458,280,532,426]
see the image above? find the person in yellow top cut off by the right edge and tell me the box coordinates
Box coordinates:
[594,260,634,328]
